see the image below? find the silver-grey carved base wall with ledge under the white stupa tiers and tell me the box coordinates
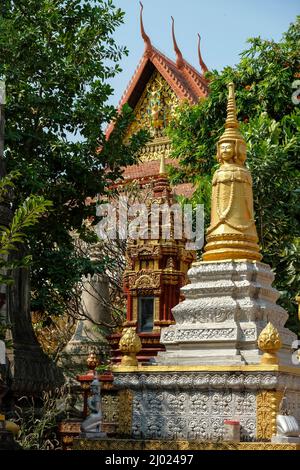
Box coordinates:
[114,368,300,442]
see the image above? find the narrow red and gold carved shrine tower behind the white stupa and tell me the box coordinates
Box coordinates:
[111,157,196,361]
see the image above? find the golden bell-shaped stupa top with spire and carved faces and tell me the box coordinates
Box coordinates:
[203,83,261,261]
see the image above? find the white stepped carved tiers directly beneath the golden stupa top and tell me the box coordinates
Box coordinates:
[157,260,296,365]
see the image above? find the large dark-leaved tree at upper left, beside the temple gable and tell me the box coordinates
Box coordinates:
[0,0,147,314]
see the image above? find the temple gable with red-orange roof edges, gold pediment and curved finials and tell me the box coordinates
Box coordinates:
[106,4,208,196]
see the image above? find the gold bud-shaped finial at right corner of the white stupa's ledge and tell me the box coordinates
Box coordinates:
[257,322,282,364]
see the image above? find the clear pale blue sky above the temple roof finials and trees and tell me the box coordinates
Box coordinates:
[110,0,300,105]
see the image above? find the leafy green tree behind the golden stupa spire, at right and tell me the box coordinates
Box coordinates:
[169,17,300,331]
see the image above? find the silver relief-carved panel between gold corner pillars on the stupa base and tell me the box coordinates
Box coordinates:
[132,390,256,440]
